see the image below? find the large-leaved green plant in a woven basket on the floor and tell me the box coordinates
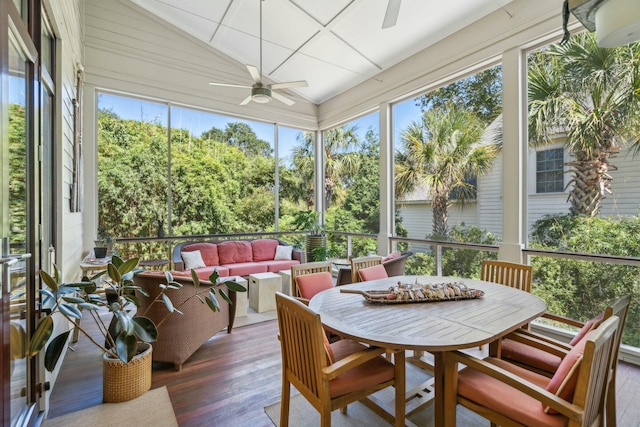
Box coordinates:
[29,255,246,402]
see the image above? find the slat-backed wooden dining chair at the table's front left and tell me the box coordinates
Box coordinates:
[276,292,405,427]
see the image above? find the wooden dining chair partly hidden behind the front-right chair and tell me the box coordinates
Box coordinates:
[495,295,631,427]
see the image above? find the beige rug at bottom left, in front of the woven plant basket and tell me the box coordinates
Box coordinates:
[43,387,178,427]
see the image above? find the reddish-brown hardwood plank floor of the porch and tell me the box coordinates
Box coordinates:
[49,321,640,427]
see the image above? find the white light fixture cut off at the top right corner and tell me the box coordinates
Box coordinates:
[596,0,640,47]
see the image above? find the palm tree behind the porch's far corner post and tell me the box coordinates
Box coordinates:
[293,125,359,208]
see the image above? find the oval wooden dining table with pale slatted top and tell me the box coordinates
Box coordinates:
[309,276,546,426]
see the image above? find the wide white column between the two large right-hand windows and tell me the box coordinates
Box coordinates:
[498,48,528,263]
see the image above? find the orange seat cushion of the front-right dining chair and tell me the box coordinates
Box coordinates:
[458,358,567,427]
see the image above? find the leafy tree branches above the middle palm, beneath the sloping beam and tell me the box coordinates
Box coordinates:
[416,65,502,126]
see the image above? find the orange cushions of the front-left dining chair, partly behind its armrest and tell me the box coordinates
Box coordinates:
[329,339,395,398]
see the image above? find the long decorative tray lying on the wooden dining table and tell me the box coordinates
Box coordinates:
[340,282,484,304]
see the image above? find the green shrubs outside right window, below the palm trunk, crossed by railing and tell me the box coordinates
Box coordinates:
[530,215,640,346]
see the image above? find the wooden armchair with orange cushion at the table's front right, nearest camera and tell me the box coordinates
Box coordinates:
[443,316,619,427]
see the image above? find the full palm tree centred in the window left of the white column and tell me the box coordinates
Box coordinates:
[395,104,499,236]
